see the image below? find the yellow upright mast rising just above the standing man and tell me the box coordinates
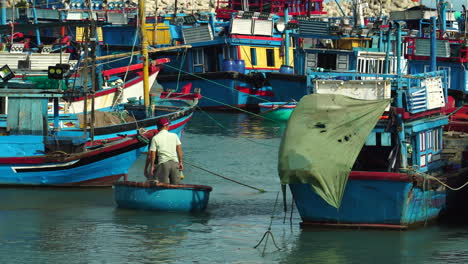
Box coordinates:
[138,0,149,108]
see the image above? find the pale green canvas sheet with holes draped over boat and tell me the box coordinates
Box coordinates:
[278,94,390,208]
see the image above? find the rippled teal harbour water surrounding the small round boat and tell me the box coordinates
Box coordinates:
[0,112,468,264]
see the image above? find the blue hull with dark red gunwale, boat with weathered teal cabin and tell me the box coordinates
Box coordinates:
[0,132,154,187]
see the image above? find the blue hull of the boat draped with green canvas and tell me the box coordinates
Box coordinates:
[289,172,446,229]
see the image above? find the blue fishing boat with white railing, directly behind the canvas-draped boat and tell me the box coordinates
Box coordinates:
[266,1,407,101]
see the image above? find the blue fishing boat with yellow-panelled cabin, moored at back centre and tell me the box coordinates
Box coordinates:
[158,0,324,109]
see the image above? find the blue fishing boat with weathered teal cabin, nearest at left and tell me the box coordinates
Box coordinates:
[0,66,155,187]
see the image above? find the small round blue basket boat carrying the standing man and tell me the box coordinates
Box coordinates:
[114,181,212,212]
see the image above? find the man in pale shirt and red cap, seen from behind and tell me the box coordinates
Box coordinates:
[145,118,184,184]
